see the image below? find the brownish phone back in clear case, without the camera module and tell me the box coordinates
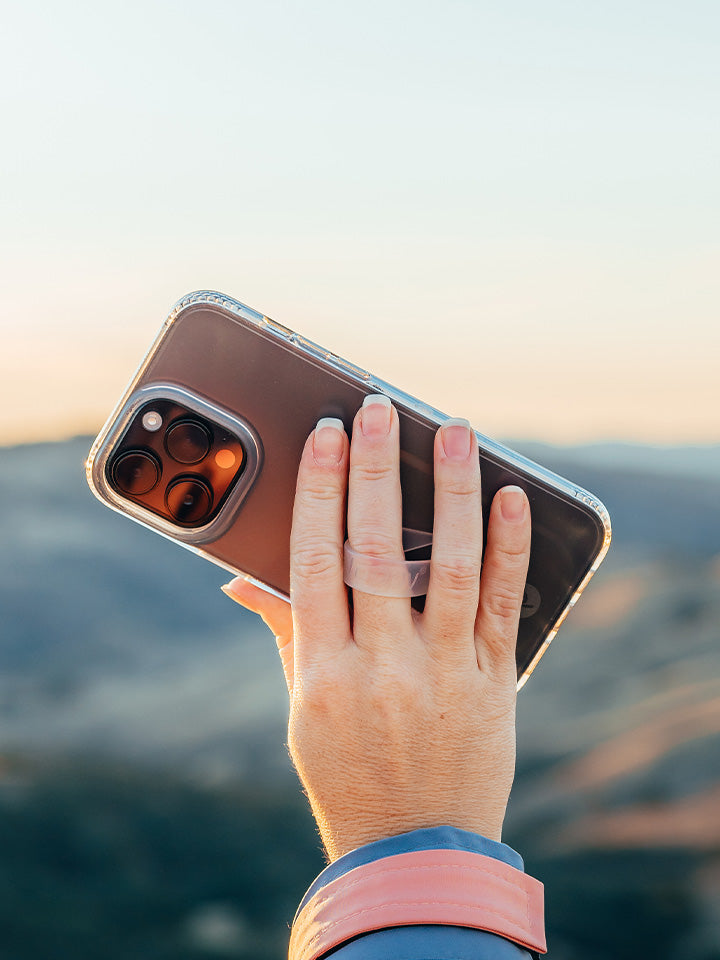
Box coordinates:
[88,297,609,679]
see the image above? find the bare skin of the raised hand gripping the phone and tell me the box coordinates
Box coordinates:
[223,397,530,861]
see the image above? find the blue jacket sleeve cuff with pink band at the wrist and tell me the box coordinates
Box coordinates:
[288,826,546,960]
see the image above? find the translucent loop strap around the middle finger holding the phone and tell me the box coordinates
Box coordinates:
[343,527,432,597]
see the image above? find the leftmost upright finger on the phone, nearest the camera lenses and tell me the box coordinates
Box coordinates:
[290,418,351,672]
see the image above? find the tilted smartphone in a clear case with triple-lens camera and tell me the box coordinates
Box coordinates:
[86,291,611,687]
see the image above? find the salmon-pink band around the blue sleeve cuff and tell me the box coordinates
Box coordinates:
[289,850,547,960]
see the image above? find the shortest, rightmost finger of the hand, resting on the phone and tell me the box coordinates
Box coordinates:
[475,487,531,677]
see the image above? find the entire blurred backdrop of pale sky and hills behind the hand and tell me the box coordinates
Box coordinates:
[0,0,720,960]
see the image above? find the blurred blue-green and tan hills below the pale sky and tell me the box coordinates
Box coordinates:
[0,438,720,960]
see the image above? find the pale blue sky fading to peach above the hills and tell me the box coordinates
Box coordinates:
[0,0,720,444]
